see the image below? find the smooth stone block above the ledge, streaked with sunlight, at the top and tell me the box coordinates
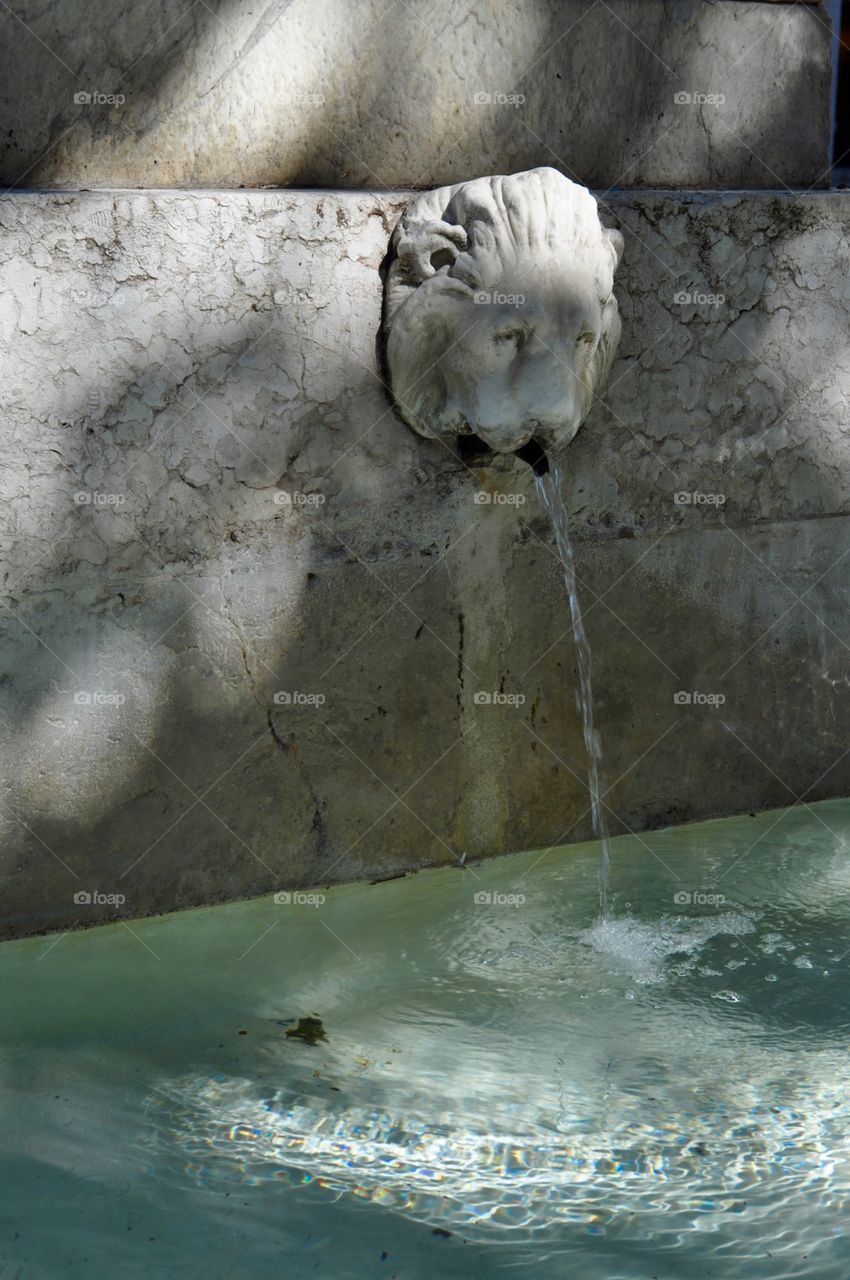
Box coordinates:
[0,0,831,188]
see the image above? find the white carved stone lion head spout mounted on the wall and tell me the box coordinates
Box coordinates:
[384,169,622,453]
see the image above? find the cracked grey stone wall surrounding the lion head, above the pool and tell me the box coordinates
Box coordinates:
[0,192,850,934]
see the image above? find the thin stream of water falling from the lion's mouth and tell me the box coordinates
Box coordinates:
[534,460,611,920]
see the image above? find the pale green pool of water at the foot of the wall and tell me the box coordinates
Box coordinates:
[0,800,850,1280]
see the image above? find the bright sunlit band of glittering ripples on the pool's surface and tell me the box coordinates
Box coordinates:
[149,1059,850,1240]
